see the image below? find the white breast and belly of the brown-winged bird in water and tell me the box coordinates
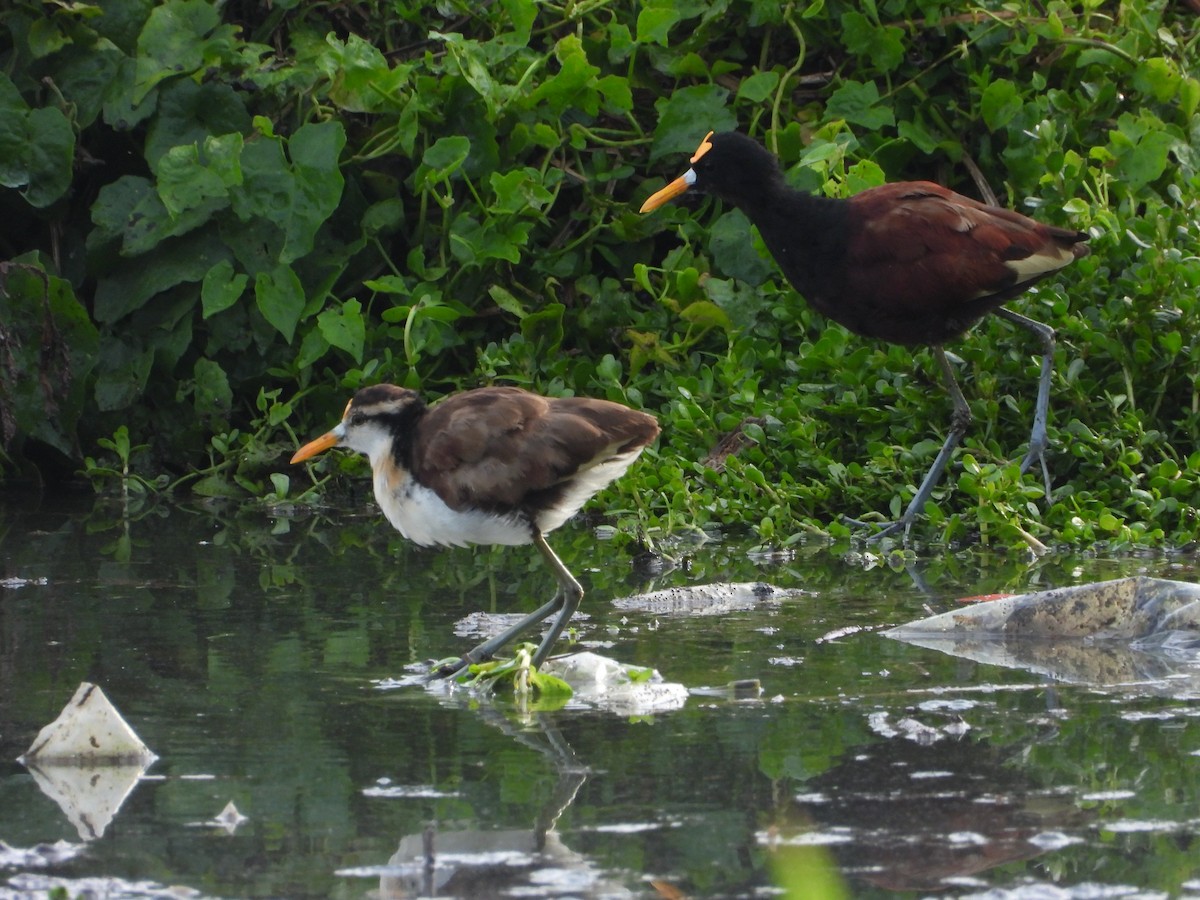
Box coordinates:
[373,469,533,547]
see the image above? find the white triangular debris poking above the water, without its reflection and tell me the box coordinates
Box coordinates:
[18,682,158,768]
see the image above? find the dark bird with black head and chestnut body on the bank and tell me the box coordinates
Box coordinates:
[642,132,1087,539]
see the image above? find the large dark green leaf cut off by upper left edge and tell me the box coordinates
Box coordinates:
[0,72,74,209]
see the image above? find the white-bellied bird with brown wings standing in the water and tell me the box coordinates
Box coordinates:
[292,384,659,677]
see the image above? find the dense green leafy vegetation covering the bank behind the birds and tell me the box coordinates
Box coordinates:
[0,0,1200,545]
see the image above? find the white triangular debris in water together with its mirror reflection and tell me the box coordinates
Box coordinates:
[18,682,158,841]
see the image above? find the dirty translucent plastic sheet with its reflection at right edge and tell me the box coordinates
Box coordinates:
[883,576,1200,694]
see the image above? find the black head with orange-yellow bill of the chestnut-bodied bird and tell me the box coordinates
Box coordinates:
[642,131,784,212]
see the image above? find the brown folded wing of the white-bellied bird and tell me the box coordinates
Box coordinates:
[413,388,659,511]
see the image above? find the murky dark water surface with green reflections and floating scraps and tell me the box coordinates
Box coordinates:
[0,496,1200,898]
